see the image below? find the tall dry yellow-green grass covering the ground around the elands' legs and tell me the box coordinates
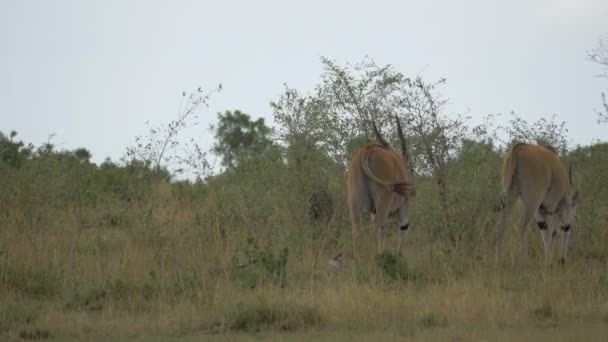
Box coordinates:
[0,162,608,341]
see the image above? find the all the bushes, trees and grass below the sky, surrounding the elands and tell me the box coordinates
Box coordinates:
[0,60,608,339]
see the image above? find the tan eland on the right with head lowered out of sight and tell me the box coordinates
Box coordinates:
[496,144,580,264]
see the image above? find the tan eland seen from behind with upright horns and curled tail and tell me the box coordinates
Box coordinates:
[347,117,415,258]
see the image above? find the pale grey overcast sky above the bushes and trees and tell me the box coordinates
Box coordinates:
[0,0,608,162]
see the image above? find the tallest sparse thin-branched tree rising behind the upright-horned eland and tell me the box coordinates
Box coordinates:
[272,58,470,240]
